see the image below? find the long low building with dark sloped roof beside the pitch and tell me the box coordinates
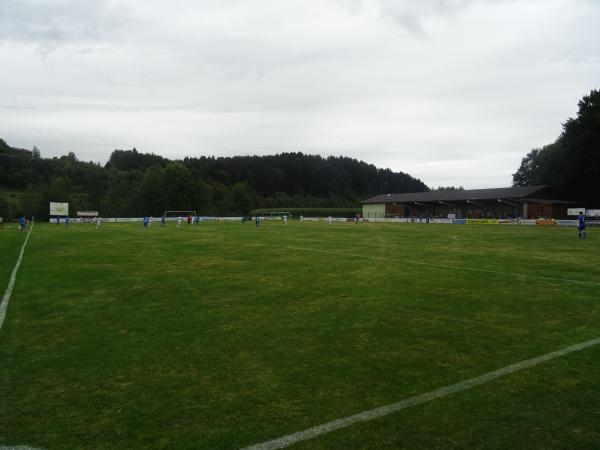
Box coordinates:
[362,185,582,219]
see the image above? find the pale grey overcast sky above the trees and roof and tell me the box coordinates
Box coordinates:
[0,0,600,188]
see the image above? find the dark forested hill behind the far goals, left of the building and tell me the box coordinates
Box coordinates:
[0,139,428,219]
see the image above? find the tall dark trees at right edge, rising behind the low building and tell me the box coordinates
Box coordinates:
[513,90,600,207]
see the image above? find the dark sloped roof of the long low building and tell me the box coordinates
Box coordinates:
[362,185,548,203]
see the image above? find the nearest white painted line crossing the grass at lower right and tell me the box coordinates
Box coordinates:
[242,338,600,450]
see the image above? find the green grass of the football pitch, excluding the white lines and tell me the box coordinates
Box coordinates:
[0,222,600,449]
